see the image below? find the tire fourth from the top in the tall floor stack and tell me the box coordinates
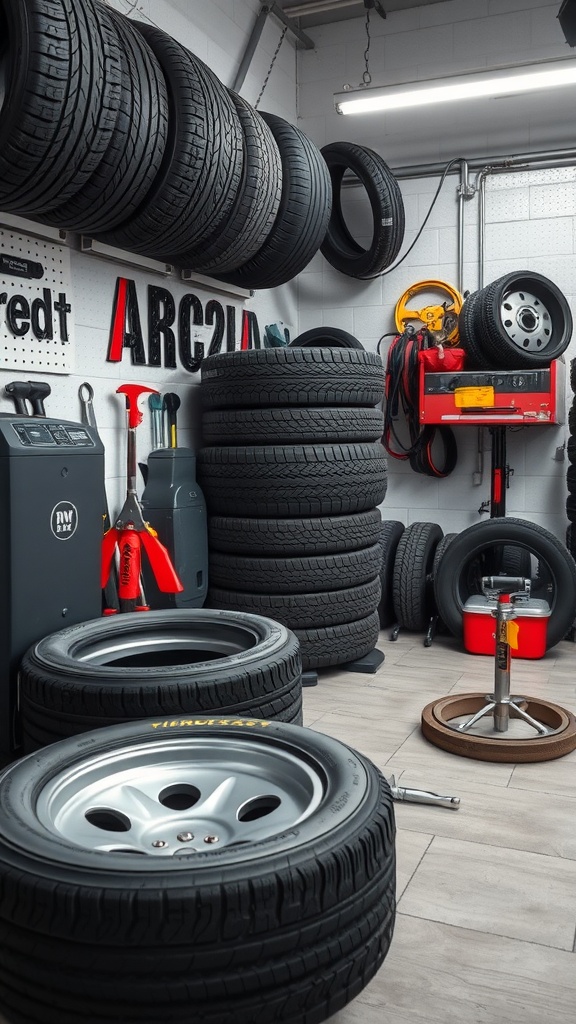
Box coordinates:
[208,509,381,557]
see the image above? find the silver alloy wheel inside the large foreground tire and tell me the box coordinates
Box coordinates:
[37,734,326,857]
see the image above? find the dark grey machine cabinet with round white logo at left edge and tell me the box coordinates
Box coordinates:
[0,414,105,763]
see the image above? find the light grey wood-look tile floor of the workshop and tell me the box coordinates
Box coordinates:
[304,632,576,1024]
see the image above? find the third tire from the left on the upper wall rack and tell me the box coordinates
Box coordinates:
[97,22,244,260]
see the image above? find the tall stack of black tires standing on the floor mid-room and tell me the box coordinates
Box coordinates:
[198,339,387,670]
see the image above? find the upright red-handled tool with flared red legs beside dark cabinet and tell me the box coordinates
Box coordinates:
[101,384,183,611]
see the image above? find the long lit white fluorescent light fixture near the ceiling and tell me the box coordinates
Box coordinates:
[334,59,576,114]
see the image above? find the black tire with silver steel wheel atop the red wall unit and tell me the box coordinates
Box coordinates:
[481,270,572,370]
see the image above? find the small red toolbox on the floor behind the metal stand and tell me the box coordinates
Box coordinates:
[462,594,550,658]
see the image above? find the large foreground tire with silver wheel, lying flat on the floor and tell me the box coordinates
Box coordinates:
[0,718,396,1024]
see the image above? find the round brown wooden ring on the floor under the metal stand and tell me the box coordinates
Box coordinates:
[421,693,576,764]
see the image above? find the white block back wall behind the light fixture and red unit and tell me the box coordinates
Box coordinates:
[298,0,576,540]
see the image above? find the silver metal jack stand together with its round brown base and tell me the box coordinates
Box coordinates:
[421,577,576,764]
